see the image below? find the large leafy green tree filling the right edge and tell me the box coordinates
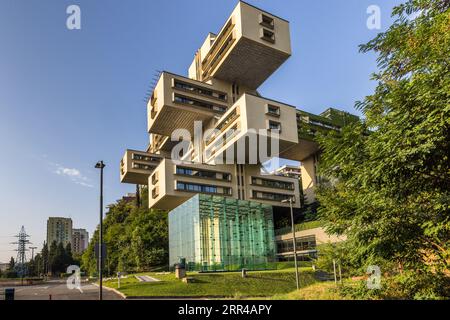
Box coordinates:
[318,0,450,298]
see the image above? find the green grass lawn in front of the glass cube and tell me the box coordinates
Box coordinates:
[105,268,316,298]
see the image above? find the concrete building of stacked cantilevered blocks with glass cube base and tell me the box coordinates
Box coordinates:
[120,1,357,270]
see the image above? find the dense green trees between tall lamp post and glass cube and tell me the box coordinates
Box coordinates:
[81,199,168,275]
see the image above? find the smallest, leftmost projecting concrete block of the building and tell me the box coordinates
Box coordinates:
[120,150,162,185]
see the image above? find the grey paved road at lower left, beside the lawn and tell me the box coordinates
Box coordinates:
[7,281,122,300]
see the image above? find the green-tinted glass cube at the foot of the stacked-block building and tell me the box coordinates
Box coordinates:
[169,194,276,271]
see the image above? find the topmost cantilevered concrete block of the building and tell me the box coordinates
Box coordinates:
[192,2,291,90]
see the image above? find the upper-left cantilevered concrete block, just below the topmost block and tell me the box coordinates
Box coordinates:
[147,72,229,136]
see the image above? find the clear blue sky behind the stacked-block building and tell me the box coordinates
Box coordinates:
[0,0,400,262]
